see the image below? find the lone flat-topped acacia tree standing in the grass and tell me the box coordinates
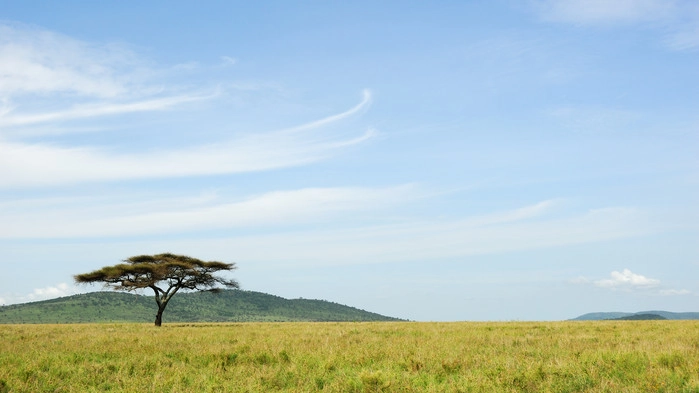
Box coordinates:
[74,253,239,326]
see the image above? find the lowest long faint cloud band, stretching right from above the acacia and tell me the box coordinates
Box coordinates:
[129,205,653,266]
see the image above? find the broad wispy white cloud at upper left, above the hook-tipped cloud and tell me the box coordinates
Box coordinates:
[0,24,220,137]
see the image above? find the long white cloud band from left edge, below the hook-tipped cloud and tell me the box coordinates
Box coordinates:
[0,185,419,238]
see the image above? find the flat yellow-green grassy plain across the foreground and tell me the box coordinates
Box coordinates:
[0,321,699,393]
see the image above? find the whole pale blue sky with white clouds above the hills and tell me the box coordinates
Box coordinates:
[0,0,699,321]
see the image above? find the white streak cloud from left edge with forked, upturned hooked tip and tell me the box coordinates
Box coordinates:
[0,91,376,187]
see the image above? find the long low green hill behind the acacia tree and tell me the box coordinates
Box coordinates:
[0,290,400,324]
